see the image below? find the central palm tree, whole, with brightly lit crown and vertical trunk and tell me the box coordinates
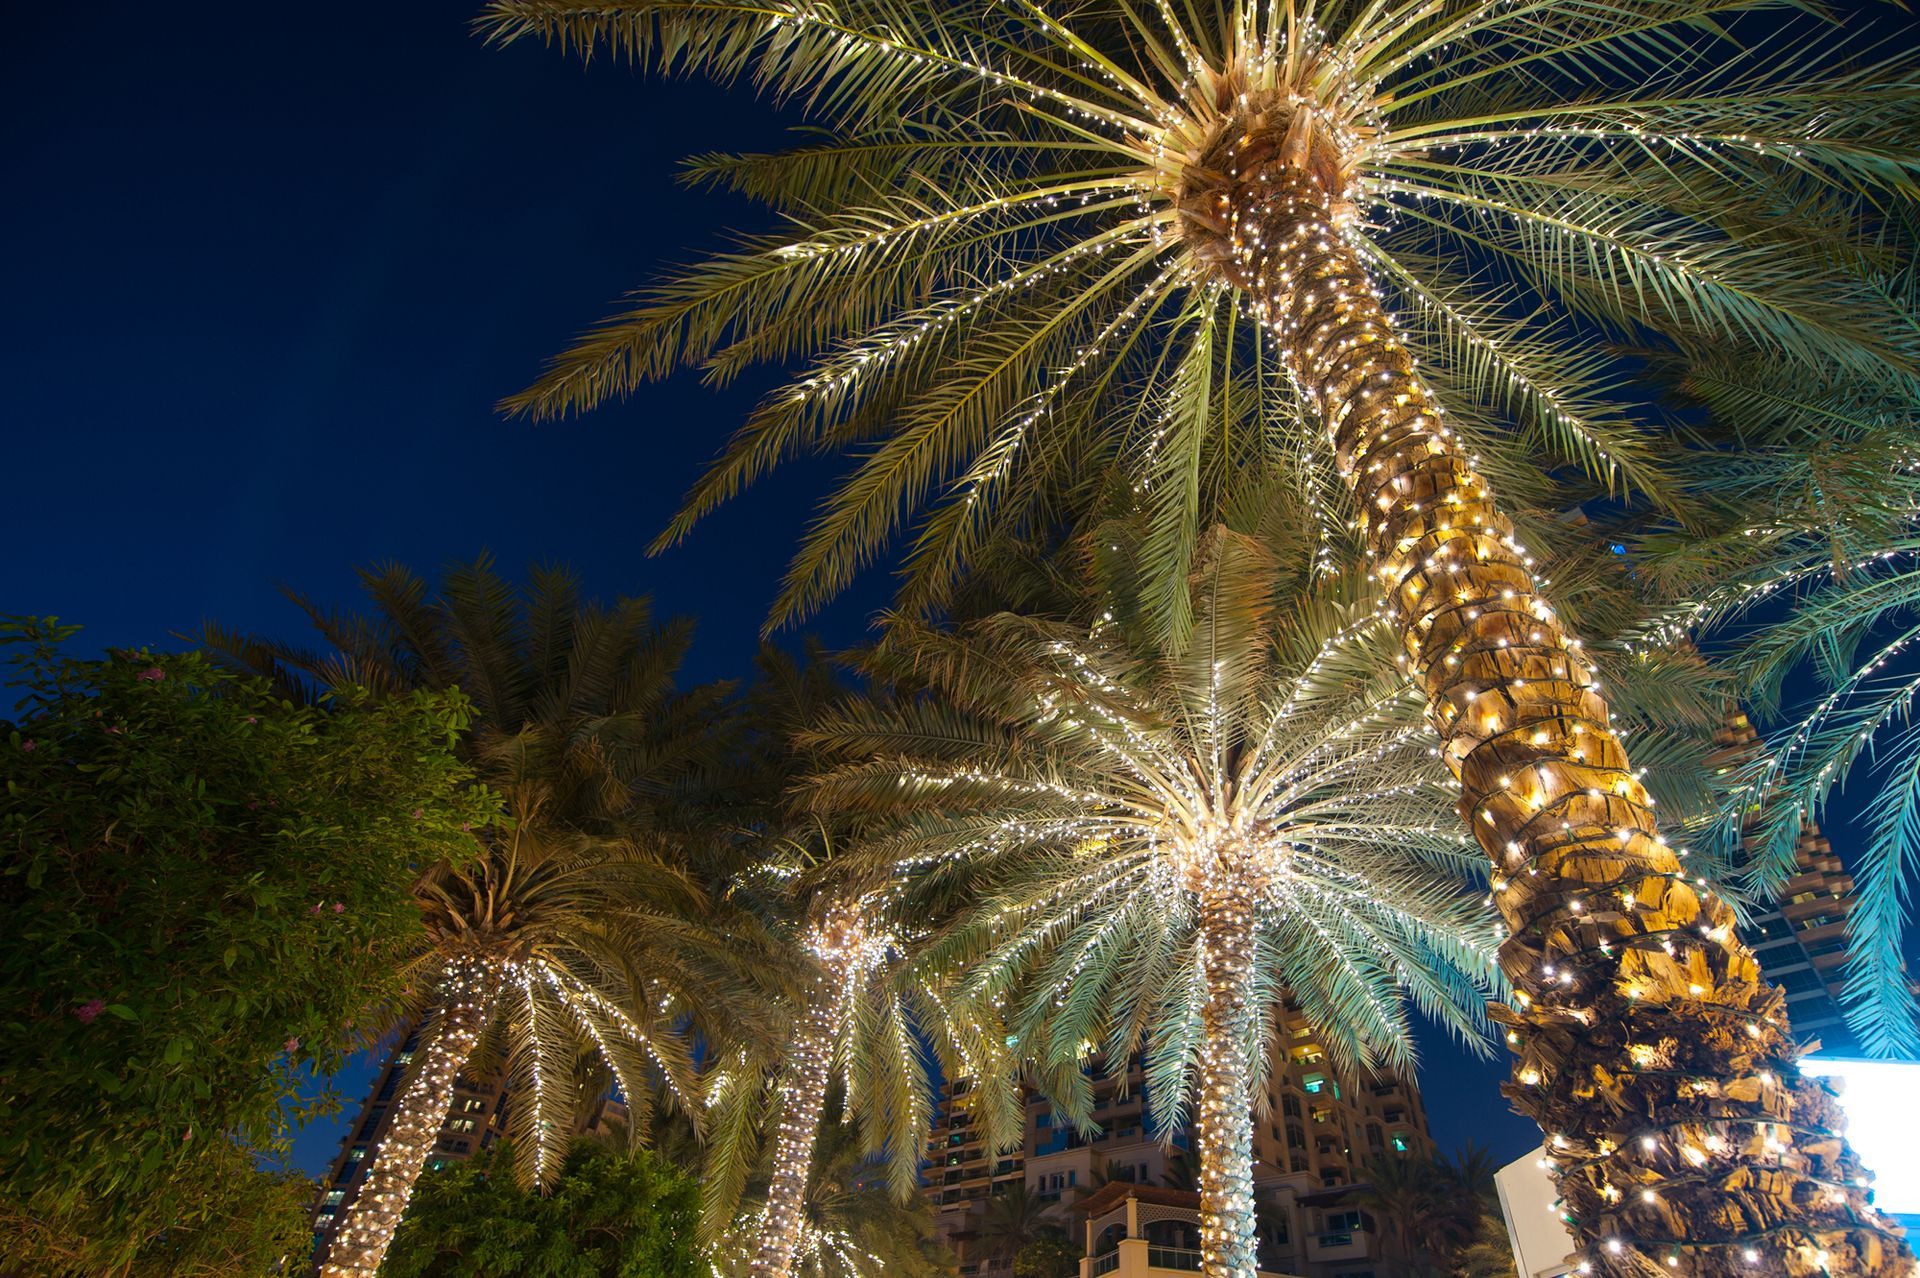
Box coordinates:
[794,526,1498,1278]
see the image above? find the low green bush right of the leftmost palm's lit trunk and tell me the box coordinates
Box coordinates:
[380,1140,710,1278]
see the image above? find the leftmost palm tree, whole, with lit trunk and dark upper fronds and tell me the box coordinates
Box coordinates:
[207,560,749,1278]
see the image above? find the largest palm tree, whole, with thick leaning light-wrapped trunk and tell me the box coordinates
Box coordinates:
[480,0,1920,1274]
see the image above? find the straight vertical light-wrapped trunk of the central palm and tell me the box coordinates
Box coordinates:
[1194,871,1254,1278]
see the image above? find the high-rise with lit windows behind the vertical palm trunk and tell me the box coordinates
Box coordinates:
[925,1000,1434,1278]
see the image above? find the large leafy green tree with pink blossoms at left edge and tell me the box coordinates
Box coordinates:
[0,620,495,1274]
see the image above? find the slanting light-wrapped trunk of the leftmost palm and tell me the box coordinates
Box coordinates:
[321,959,501,1278]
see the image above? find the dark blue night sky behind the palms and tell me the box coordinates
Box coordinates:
[0,0,1538,1167]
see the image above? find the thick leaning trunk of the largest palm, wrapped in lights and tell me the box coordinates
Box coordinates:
[1196,162,1912,1278]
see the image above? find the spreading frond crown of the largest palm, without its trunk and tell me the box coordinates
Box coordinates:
[482,0,1920,620]
